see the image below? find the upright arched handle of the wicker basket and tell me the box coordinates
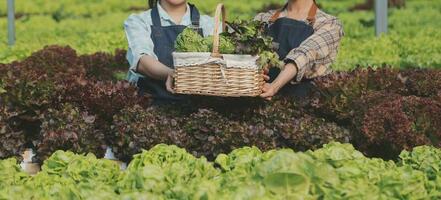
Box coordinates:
[211,3,227,57]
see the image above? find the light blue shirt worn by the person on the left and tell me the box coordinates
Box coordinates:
[124,3,214,83]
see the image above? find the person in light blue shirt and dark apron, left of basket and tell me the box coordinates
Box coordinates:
[124,0,214,102]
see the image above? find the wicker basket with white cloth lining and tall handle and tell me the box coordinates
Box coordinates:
[173,4,264,97]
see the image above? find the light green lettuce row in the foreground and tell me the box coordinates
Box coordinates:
[0,143,441,200]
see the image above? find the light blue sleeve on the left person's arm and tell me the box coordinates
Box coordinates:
[124,14,157,71]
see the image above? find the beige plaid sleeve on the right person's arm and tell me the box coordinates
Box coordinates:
[285,18,344,82]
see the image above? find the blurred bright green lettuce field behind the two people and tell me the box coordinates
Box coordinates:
[0,0,441,70]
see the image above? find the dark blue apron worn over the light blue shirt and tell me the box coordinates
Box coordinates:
[137,4,202,104]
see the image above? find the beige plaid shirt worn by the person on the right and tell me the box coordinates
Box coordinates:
[255,10,344,82]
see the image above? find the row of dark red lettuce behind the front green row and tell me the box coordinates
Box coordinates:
[0,46,441,163]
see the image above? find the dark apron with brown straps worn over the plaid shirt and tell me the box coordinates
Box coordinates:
[266,3,318,97]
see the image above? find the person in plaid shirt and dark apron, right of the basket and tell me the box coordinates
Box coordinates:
[255,0,344,99]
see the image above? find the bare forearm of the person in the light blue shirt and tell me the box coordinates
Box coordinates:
[137,55,173,80]
